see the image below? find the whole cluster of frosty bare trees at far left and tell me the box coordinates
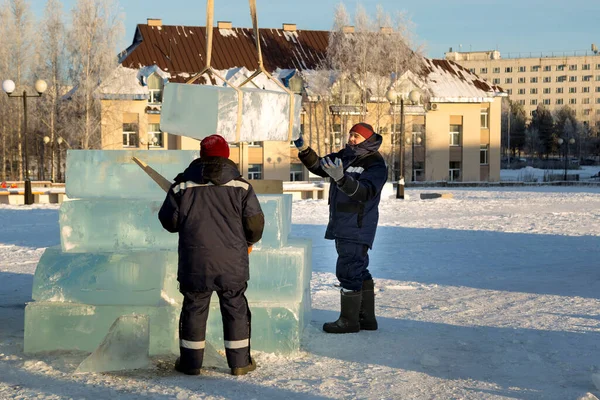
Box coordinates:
[0,0,124,180]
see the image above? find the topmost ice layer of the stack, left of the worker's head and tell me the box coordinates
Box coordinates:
[66,150,200,200]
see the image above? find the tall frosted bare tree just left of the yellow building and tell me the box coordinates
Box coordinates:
[67,0,123,149]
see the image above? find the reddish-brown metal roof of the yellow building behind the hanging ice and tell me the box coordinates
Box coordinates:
[121,24,329,81]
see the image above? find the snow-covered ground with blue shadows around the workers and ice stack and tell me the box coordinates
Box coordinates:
[0,186,600,400]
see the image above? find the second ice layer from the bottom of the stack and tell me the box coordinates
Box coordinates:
[32,238,311,306]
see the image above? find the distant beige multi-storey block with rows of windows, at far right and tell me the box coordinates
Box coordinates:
[445,50,600,128]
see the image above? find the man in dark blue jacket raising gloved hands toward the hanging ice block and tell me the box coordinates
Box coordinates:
[294,122,387,333]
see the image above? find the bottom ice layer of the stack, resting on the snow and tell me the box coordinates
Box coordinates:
[24,296,310,355]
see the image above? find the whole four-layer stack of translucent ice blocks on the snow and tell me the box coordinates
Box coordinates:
[25,150,311,354]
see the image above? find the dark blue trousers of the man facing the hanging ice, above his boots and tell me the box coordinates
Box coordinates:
[335,239,373,290]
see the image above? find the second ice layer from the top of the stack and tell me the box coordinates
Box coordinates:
[59,195,291,253]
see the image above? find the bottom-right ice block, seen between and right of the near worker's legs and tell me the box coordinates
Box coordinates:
[206,296,310,354]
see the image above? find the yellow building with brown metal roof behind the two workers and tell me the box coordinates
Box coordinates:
[99,20,505,182]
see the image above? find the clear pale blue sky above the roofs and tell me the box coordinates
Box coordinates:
[31,0,600,58]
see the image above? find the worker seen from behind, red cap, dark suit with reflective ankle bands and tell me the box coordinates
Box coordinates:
[158,135,265,375]
